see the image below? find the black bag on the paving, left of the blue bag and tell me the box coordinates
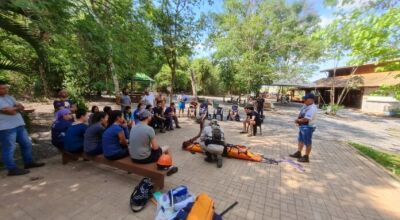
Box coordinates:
[130,177,154,212]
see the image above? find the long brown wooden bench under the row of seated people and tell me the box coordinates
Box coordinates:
[61,151,167,189]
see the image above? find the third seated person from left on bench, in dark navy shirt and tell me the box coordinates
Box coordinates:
[83,112,108,156]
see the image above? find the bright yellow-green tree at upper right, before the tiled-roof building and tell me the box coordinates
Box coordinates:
[319,0,400,105]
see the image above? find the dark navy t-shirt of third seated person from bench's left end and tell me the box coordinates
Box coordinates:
[83,122,104,152]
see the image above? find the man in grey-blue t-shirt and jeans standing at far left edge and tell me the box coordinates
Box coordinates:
[0,81,44,176]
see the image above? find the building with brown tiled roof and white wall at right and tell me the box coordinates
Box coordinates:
[312,64,400,113]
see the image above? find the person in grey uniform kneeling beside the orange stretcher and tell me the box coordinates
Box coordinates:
[200,119,225,168]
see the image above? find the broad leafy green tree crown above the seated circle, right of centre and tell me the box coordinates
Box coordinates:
[211,0,320,92]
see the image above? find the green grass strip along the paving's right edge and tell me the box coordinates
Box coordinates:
[349,142,400,176]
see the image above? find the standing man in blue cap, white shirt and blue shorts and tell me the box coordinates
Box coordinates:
[289,93,318,162]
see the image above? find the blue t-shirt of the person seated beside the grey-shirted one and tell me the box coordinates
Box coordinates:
[102,124,124,157]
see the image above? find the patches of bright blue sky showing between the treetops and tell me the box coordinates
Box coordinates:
[196,0,356,81]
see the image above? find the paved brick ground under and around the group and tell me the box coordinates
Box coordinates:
[0,106,400,220]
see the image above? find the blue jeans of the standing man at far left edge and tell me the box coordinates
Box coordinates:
[0,126,32,170]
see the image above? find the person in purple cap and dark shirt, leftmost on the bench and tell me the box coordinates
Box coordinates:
[51,108,73,150]
